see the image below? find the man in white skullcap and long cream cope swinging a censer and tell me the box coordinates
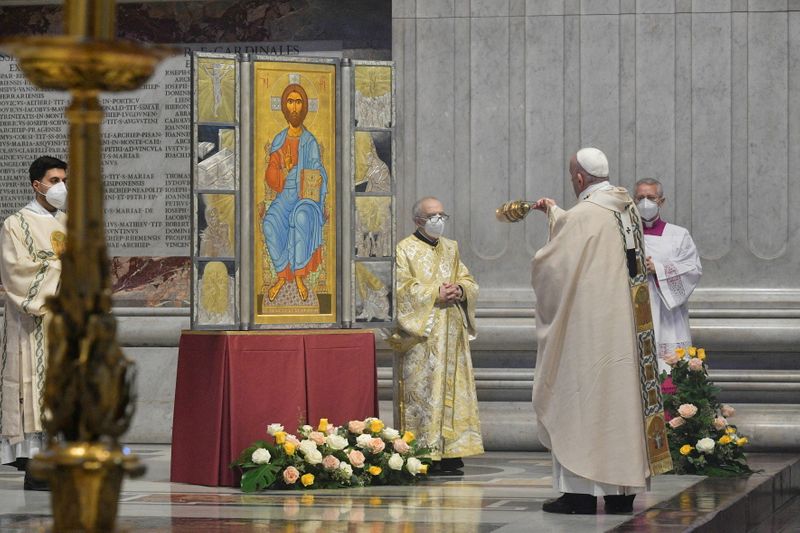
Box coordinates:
[532,148,672,514]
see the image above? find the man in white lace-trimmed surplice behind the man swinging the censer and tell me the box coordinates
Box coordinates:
[634,178,703,372]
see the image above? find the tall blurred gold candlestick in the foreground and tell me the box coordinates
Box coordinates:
[0,0,177,531]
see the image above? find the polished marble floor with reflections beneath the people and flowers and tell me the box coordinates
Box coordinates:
[0,445,800,533]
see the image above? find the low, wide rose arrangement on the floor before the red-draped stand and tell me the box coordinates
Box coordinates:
[230,418,430,492]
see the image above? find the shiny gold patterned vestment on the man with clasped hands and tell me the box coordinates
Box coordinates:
[389,235,483,460]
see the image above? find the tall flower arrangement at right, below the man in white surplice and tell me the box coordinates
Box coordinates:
[660,346,753,477]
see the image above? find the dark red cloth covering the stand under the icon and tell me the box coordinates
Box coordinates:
[170,330,378,486]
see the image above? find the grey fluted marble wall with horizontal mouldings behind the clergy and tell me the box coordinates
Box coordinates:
[386,0,800,447]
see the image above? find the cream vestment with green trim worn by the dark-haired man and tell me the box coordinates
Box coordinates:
[0,208,67,446]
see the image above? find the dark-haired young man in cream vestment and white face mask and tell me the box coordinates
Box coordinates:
[0,156,67,490]
